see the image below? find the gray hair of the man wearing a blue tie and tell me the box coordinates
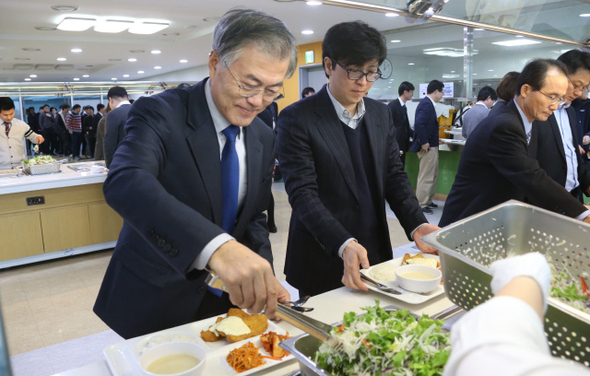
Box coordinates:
[212,9,297,77]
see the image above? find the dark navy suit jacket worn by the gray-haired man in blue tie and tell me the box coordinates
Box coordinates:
[94,80,274,338]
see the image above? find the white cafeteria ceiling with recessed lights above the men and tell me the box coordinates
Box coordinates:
[0,0,590,83]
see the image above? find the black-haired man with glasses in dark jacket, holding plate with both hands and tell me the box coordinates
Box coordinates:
[277,21,438,296]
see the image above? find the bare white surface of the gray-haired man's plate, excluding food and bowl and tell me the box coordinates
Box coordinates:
[103,315,294,376]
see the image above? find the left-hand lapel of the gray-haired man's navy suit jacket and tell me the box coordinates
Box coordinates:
[187,80,223,226]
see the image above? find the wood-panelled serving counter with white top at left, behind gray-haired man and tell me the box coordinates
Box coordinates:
[0,162,123,269]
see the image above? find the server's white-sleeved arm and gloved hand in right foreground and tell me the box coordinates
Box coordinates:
[443,252,590,376]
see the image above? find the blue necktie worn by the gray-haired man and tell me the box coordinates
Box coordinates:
[221,125,240,234]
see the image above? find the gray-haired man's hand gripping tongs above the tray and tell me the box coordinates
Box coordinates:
[209,240,282,318]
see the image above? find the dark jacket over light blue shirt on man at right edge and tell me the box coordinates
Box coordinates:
[531,106,590,195]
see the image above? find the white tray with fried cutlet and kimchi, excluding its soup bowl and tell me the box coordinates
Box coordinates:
[103,309,293,376]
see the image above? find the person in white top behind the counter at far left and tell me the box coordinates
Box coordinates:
[0,97,45,170]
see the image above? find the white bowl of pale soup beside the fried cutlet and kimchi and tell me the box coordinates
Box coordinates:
[139,341,206,376]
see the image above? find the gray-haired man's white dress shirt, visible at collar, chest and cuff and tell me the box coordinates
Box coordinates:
[193,81,248,270]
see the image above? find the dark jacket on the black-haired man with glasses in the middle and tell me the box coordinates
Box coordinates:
[277,86,427,294]
